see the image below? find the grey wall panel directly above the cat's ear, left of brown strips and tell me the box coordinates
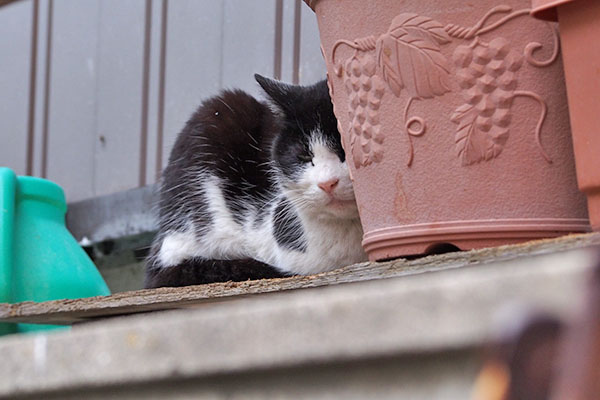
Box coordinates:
[222,0,275,94]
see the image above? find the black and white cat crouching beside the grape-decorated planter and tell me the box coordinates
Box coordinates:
[146,75,366,287]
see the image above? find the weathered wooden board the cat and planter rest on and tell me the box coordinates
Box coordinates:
[0,233,600,324]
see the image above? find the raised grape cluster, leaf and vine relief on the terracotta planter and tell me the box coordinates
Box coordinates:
[332,6,558,168]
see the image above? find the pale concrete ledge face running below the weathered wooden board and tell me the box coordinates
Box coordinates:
[0,245,597,399]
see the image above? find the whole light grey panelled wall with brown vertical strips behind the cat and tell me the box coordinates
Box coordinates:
[0,0,325,201]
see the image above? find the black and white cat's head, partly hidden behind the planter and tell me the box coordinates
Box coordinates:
[255,75,358,219]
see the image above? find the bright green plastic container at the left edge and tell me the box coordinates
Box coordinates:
[0,168,110,335]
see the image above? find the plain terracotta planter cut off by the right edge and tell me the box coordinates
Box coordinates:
[532,0,600,230]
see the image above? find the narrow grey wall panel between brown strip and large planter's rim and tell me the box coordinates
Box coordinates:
[299,4,327,84]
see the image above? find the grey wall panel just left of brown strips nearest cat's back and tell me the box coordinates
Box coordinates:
[94,0,146,195]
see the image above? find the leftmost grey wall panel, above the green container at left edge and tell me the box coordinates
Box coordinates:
[0,0,33,174]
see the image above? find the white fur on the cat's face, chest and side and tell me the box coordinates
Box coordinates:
[158,135,366,275]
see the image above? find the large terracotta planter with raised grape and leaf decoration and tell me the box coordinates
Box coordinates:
[307,0,590,260]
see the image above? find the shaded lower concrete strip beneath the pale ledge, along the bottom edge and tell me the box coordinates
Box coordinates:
[4,351,480,400]
